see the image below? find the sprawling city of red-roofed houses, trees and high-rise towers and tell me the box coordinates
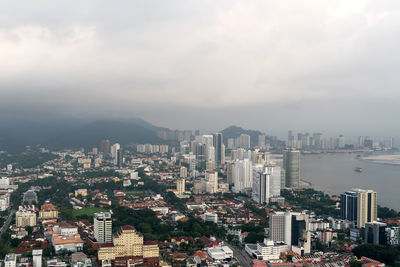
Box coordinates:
[0,129,400,267]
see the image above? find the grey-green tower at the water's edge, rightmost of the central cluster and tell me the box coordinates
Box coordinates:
[283,148,300,188]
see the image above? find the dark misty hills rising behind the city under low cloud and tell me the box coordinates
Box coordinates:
[0,118,261,152]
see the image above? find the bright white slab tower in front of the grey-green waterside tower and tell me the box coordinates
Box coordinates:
[252,165,281,204]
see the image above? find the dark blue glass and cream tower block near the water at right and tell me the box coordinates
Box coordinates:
[341,189,378,228]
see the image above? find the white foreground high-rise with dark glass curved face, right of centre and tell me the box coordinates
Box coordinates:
[269,212,311,255]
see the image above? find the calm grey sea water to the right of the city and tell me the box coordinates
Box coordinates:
[301,153,400,210]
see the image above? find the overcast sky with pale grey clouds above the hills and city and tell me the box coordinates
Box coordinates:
[0,0,400,136]
